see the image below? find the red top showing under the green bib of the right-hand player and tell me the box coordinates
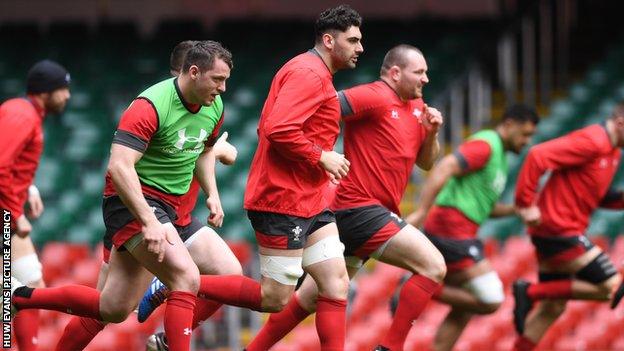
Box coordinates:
[424,140,492,240]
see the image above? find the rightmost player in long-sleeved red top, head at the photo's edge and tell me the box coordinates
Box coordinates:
[513,103,624,350]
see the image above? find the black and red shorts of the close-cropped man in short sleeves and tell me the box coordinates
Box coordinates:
[336,205,407,259]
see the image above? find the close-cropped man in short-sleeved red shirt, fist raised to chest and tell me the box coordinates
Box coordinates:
[247,45,445,351]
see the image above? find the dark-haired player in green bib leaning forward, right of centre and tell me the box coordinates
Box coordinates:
[407,105,539,350]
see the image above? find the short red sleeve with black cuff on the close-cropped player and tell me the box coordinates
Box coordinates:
[338,85,379,121]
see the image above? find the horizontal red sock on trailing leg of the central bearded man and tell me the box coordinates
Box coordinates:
[198,275,262,311]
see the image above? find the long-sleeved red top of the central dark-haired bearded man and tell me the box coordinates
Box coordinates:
[244,50,340,218]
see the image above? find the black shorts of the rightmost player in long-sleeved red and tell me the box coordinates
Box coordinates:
[531,235,594,265]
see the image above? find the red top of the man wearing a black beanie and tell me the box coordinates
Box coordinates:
[0,98,45,222]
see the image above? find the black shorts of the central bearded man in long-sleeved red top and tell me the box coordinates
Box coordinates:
[247,209,336,250]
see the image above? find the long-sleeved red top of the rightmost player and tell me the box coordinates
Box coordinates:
[516,124,624,236]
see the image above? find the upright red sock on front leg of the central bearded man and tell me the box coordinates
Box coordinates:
[316,295,347,351]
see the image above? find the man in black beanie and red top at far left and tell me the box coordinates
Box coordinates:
[0,60,70,351]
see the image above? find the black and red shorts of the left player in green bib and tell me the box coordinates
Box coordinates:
[102,195,177,251]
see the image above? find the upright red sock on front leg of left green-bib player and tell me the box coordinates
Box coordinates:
[164,291,197,351]
